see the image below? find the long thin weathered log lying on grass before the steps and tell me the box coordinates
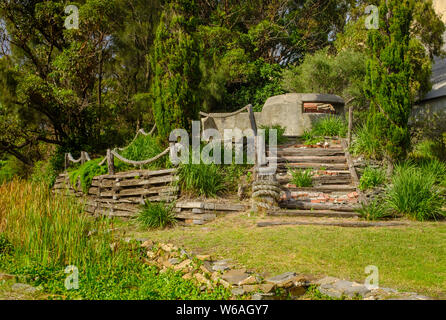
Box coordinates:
[257,221,407,228]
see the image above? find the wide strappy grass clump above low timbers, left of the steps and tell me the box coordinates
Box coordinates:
[178,161,225,197]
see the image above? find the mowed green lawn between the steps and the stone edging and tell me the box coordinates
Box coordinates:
[126,214,446,298]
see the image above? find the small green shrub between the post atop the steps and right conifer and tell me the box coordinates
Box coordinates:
[351,123,383,159]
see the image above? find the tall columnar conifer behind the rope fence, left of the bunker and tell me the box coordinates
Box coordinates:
[152,5,201,142]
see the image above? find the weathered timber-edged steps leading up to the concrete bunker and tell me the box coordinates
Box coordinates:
[269,139,360,218]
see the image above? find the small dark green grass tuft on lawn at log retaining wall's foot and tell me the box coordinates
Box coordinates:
[137,201,177,229]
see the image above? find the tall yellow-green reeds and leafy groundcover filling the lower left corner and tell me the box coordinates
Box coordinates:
[0,181,230,300]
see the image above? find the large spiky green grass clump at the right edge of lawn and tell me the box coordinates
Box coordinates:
[386,163,445,221]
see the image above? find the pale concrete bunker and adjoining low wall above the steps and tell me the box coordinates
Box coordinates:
[203,93,344,136]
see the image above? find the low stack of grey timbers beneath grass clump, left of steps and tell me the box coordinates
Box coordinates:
[175,201,249,225]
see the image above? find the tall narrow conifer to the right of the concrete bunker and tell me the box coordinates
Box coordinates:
[365,0,414,172]
